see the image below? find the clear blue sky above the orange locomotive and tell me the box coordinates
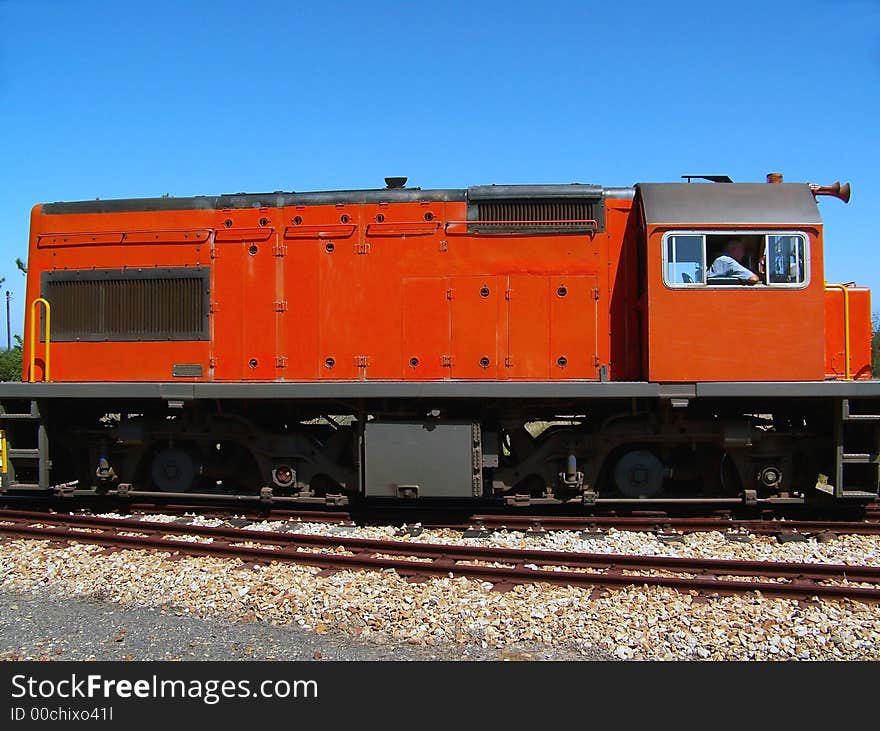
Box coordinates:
[0,0,880,342]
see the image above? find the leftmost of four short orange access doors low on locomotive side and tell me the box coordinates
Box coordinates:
[402,277,451,380]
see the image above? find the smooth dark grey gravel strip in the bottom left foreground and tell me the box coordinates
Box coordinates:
[0,590,600,661]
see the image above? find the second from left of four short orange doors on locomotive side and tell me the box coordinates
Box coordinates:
[448,276,498,379]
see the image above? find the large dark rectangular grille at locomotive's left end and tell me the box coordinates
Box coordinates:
[43,268,208,341]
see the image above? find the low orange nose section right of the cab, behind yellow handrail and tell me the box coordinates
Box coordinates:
[825,286,871,379]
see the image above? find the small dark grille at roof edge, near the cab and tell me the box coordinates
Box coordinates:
[469,198,597,231]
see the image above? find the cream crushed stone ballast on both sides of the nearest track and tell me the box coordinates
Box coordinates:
[0,529,880,660]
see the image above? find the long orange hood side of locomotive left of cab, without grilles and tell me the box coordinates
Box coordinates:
[24,201,630,381]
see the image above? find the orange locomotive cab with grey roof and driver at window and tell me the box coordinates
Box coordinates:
[638,183,825,382]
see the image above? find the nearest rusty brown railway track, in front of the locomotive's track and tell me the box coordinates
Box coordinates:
[0,510,880,602]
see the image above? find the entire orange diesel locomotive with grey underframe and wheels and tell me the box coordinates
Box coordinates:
[0,176,880,504]
